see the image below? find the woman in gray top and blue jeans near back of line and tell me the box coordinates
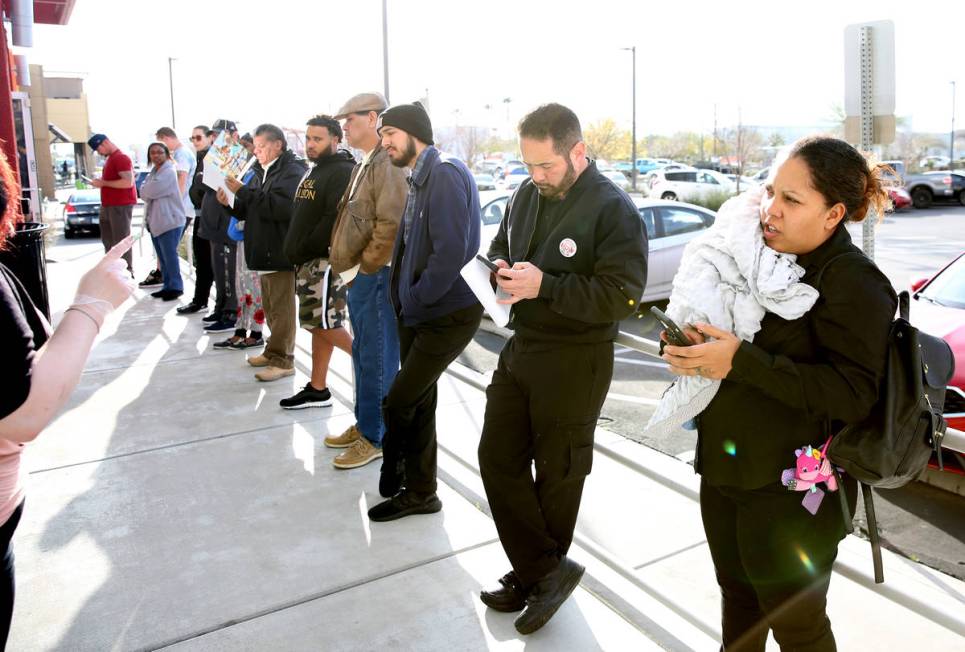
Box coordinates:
[141,143,186,301]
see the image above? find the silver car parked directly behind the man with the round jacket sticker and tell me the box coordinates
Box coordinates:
[479,192,716,302]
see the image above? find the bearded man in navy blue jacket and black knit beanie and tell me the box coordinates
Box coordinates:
[369,103,482,521]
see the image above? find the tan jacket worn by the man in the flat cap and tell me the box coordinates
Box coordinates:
[329,145,409,274]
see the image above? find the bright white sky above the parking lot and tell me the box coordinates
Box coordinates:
[14,0,965,149]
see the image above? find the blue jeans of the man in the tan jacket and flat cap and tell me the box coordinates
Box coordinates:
[348,267,399,448]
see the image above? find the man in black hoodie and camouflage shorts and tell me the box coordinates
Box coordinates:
[280,115,355,410]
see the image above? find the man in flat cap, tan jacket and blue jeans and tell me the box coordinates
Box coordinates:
[325,93,408,469]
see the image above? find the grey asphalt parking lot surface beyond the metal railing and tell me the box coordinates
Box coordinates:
[460,205,965,579]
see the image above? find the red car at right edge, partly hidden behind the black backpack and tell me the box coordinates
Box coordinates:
[911,252,965,474]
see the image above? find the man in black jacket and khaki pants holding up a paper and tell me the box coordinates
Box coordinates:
[217,124,308,382]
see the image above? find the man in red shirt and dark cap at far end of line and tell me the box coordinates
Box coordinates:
[87,134,137,276]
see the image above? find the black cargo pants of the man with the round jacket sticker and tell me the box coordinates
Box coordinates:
[479,337,613,587]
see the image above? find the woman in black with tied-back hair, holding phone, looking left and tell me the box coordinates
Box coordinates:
[663,137,897,650]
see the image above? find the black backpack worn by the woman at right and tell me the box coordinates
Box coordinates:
[815,254,955,584]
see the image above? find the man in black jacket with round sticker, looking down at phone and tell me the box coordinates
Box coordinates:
[479,104,647,634]
